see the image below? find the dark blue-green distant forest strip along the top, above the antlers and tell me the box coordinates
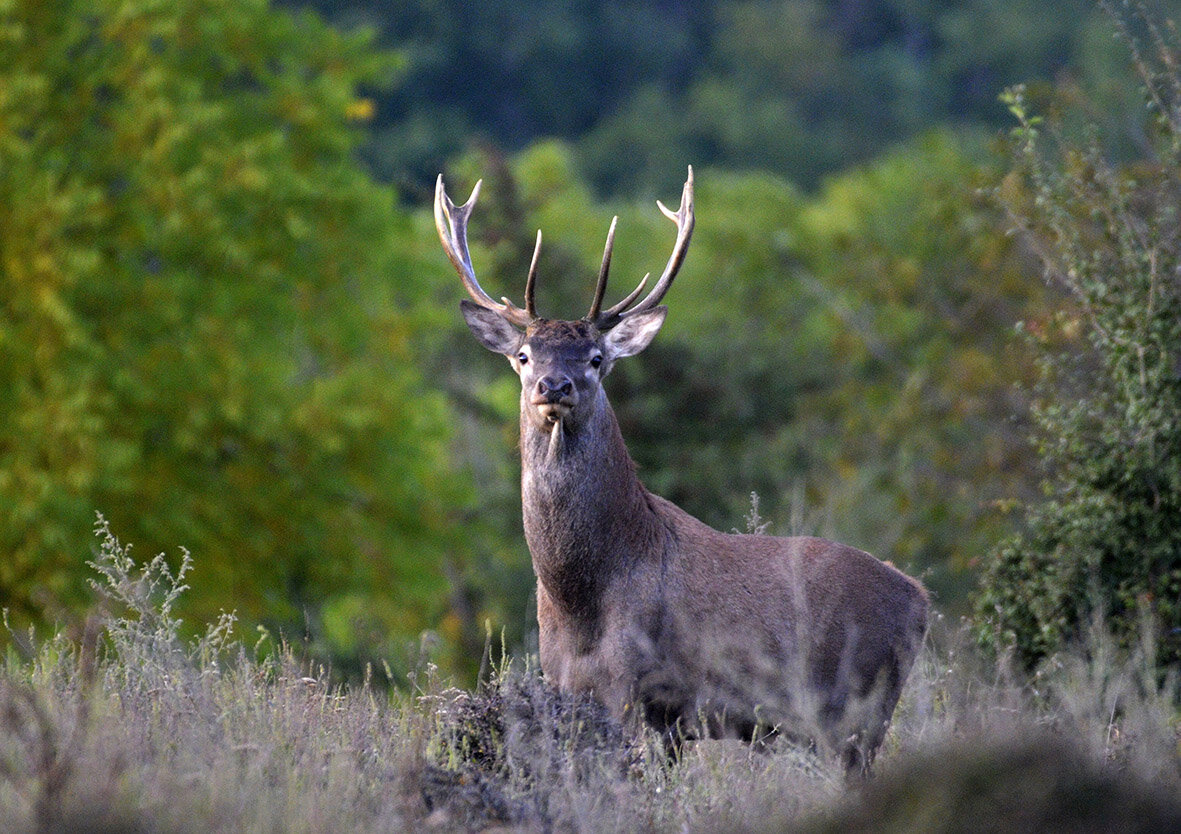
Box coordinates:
[282,0,1179,196]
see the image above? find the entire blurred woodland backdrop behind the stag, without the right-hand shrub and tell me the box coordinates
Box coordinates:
[0,0,1177,671]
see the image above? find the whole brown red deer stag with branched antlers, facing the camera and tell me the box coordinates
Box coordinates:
[435,168,928,773]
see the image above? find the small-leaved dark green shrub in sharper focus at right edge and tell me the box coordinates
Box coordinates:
[978,6,1181,663]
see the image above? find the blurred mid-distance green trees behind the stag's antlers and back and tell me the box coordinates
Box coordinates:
[437,133,1044,606]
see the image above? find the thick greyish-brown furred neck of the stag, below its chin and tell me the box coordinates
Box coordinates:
[521,389,659,615]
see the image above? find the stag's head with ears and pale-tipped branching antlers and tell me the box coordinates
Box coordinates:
[435,168,693,445]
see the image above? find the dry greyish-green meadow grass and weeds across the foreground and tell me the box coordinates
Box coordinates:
[0,523,1181,834]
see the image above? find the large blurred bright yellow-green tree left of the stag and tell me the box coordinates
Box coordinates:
[0,0,463,670]
